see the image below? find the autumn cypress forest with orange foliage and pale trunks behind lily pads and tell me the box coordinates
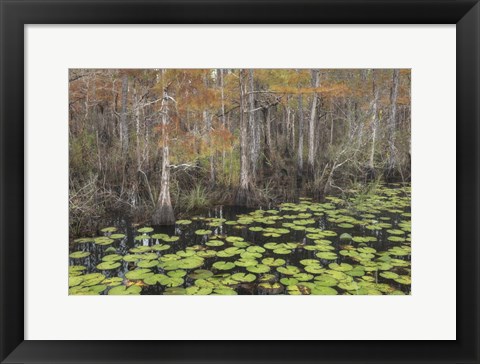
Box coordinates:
[69,69,411,235]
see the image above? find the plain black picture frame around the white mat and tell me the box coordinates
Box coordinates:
[0,0,480,363]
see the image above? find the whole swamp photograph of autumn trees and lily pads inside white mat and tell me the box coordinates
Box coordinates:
[65,69,411,295]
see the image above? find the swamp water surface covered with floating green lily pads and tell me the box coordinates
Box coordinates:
[69,185,411,295]
